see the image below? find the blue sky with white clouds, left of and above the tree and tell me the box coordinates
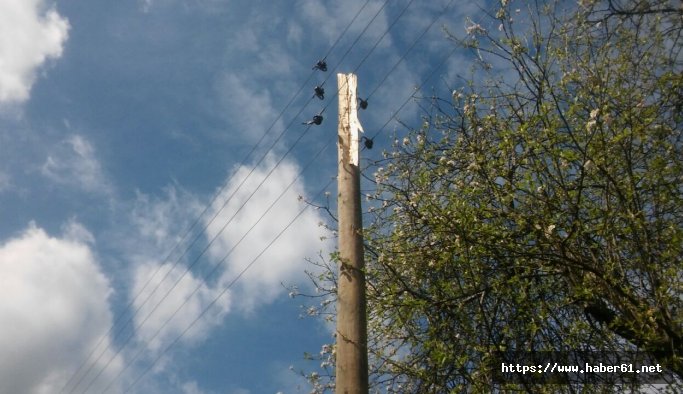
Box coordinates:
[0,0,492,394]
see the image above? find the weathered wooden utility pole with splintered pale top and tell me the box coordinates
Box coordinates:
[336,74,368,394]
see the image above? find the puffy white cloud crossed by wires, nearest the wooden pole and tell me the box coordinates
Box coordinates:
[207,155,324,311]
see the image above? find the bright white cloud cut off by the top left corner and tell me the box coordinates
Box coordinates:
[0,0,69,103]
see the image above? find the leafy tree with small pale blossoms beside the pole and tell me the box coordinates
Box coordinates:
[300,0,683,393]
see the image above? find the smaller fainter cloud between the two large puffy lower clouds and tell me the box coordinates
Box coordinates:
[121,186,230,358]
